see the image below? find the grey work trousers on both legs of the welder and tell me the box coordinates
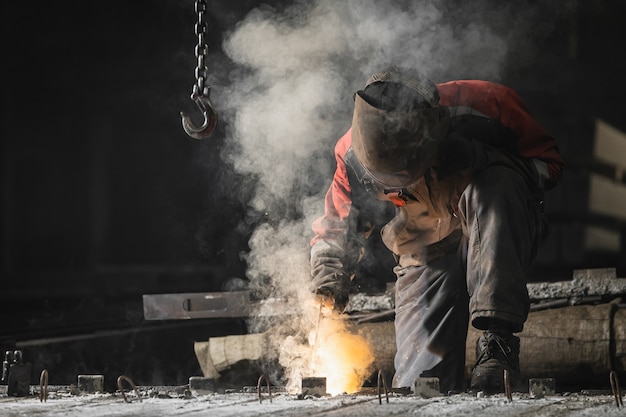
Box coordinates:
[393,165,545,392]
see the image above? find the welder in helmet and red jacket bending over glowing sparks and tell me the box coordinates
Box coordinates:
[311,68,563,392]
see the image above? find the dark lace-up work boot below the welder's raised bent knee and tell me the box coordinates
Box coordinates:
[470,330,521,394]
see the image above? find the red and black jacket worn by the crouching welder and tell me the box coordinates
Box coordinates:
[311,80,563,288]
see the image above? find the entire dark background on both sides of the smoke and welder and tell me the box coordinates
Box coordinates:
[0,0,626,384]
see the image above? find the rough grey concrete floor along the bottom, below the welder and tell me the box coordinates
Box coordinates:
[0,387,625,417]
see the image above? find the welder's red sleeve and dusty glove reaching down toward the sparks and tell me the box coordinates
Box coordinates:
[311,131,352,291]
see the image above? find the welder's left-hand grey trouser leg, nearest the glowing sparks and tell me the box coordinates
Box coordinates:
[393,249,468,392]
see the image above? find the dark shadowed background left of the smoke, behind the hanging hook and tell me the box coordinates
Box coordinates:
[0,1,260,384]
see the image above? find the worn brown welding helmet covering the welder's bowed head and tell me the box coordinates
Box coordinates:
[352,69,449,188]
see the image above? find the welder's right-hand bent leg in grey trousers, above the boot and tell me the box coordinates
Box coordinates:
[459,166,544,332]
